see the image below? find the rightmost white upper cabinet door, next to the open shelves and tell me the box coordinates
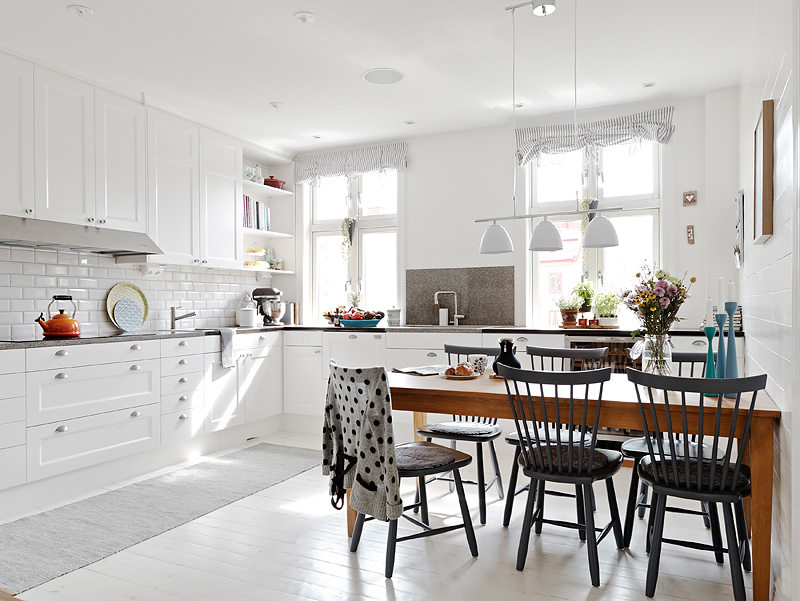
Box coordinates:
[199,128,243,269]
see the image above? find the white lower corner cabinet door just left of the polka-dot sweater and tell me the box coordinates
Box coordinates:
[283,342,329,416]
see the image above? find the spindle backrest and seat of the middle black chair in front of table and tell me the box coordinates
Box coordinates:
[498,360,611,477]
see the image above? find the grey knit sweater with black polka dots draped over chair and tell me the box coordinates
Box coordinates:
[322,361,403,520]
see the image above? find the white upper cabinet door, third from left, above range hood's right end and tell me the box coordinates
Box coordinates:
[94,89,147,233]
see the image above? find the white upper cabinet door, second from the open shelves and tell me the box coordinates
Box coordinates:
[147,109,200,265]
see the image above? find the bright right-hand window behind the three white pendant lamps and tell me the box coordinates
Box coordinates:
[529,141,661,329]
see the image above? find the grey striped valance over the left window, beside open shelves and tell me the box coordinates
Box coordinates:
[294,142,408,183]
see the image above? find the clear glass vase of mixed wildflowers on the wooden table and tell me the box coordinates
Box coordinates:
[620,266,697,376]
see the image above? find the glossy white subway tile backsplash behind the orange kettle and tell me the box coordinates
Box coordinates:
[0,247,260,340]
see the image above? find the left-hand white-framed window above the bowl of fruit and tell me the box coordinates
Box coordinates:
[310,169,398,316]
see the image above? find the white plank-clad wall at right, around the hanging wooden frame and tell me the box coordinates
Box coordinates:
[739,0,797,599]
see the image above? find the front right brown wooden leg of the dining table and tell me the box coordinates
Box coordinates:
[750,418,774,601]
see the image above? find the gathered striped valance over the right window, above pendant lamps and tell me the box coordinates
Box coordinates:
[516,106,675,165]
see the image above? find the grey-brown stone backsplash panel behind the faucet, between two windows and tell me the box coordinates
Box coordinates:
[406,267,514,326]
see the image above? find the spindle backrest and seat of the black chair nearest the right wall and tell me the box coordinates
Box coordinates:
[627,368,767,494]
